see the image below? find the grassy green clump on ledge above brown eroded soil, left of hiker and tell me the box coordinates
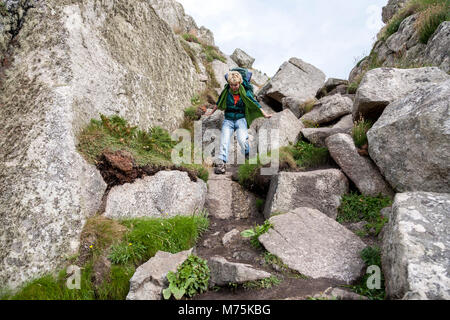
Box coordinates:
[77,115,208,181]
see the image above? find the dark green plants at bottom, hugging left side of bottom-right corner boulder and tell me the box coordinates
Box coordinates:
[344,247,386,300]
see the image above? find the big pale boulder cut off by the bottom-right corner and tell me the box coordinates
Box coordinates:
[382,192,450,300]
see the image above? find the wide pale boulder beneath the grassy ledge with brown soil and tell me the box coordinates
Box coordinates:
[105,171,207,219]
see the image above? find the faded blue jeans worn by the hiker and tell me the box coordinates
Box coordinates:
[218,118,250,163]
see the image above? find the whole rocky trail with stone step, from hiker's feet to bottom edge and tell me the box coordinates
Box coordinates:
[188,165,370,300]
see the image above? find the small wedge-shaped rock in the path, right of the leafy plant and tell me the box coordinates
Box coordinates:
[208,256,271,287]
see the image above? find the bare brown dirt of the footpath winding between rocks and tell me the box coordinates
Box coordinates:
[194,166,350,300]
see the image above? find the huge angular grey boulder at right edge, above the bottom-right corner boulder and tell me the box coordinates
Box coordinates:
[367,80,450,193]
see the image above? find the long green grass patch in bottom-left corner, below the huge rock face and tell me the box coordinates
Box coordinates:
[0,212,209,300]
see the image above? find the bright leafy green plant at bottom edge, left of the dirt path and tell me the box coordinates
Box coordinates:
[163,255,210,300]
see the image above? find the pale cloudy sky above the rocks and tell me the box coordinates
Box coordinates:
[177,0,387,79]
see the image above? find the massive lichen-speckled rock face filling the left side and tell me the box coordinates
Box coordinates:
[0,0,202,287]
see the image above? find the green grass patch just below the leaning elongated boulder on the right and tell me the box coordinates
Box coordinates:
[336,193,392,236]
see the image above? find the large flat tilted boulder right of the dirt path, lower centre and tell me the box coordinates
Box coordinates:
[258,207,366,283]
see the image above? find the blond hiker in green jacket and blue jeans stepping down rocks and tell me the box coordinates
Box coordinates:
[205,69,272,174]
